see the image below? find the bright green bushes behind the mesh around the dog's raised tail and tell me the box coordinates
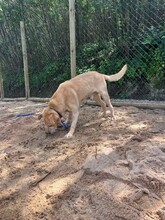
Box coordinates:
[77,26,165,98]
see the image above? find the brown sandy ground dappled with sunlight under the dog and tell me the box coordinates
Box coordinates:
[0,102,165,220]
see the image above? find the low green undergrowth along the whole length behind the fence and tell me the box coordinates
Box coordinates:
[2,29,165,99]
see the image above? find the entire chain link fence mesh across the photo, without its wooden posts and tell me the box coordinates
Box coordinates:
[0,0,165,100]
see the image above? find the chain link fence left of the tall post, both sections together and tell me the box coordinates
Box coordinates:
[0,0,70,98]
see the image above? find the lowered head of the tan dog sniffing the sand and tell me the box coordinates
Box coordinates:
[38,107,61,134]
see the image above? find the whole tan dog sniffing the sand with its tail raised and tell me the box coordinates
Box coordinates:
[40,65,127,138]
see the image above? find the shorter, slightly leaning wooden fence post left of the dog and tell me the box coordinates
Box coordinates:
[20,21,30,99]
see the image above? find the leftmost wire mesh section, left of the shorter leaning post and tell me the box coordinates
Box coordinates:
[0,1,25,97]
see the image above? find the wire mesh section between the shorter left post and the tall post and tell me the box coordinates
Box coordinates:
[24,1,70,97]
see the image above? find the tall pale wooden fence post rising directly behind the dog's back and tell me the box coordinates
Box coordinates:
[69,0,76,78]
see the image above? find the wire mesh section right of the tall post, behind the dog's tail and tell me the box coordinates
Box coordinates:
[76,0,165,100]
